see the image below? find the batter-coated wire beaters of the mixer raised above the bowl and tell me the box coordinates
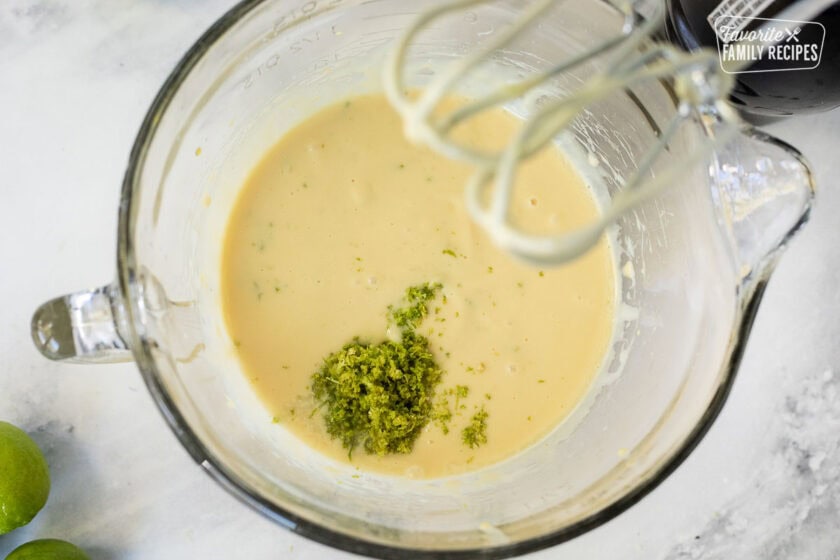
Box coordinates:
[384,0,829,264]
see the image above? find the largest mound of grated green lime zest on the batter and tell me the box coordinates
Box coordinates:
[311,283,443,456]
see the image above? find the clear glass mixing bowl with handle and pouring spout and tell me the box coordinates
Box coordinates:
[32,0,813,559]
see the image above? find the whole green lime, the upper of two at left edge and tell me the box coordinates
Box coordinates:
[0,422,50,535]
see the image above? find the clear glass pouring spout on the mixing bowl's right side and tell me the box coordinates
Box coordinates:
[709,126,815,289]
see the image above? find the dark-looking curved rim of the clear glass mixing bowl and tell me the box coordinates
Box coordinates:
[117,0,767,560]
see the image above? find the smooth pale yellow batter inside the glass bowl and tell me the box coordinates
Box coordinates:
[222,96,615,477]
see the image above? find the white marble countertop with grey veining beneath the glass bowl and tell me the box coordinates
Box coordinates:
[0,0,840,560]
